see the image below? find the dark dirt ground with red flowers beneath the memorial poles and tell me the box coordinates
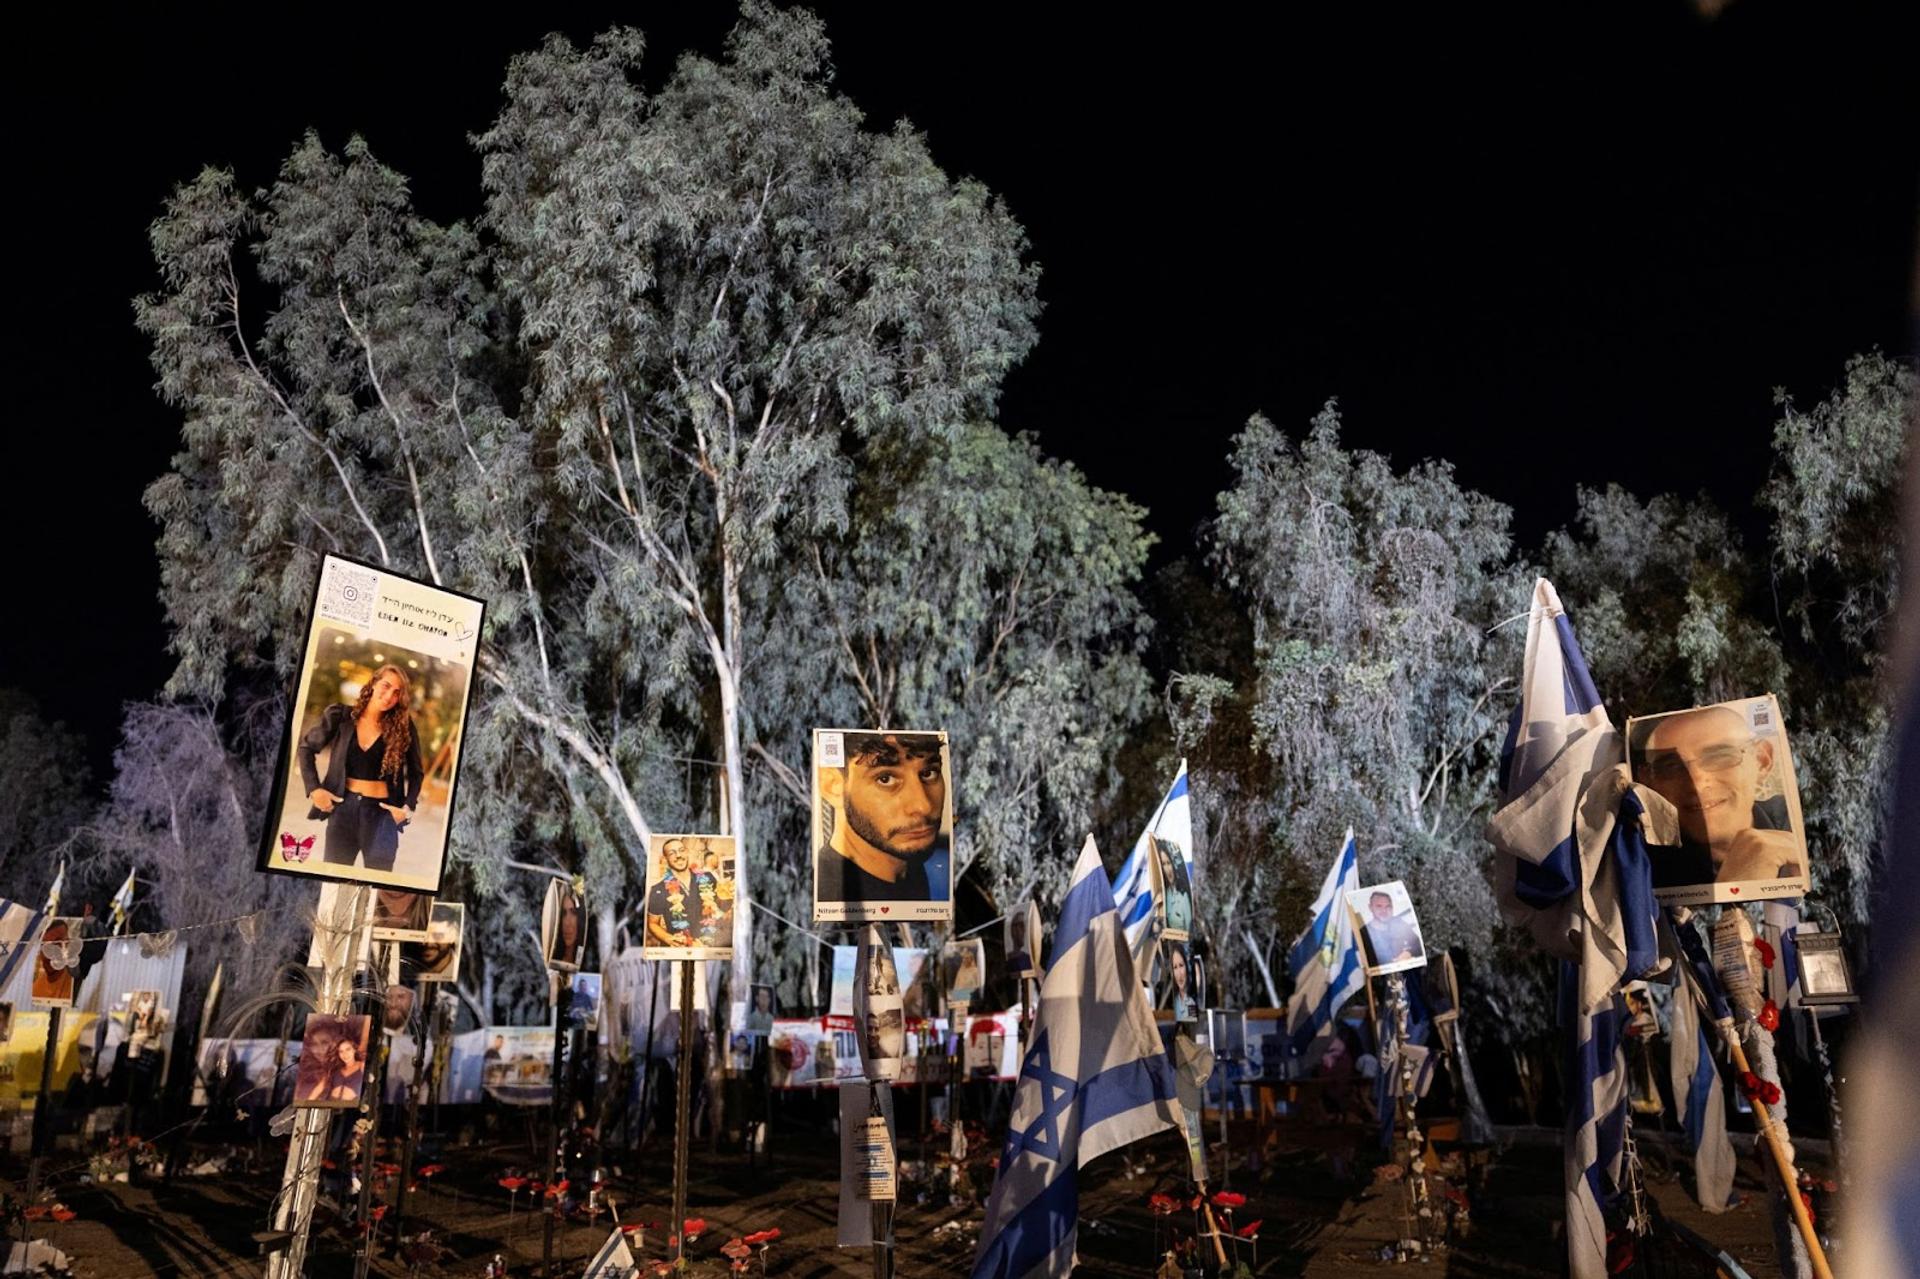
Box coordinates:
[4,1116,1820,1279]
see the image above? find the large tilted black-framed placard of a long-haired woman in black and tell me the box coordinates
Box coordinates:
[259,555,486,893]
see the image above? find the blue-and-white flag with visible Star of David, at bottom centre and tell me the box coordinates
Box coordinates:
[973,835,1181,1279]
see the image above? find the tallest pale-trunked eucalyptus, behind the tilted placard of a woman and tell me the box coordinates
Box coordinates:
[138,4,1037,979]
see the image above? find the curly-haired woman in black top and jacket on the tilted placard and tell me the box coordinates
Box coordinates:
[300,666,426,870]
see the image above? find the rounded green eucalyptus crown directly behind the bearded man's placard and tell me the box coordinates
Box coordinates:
[766,424,1152,906]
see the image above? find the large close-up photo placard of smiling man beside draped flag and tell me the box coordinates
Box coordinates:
[1626,693,1809,906]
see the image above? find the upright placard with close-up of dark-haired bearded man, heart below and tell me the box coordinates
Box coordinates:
[812,728,954,924]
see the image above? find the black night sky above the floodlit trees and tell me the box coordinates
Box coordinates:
[15,0,1920,772]
